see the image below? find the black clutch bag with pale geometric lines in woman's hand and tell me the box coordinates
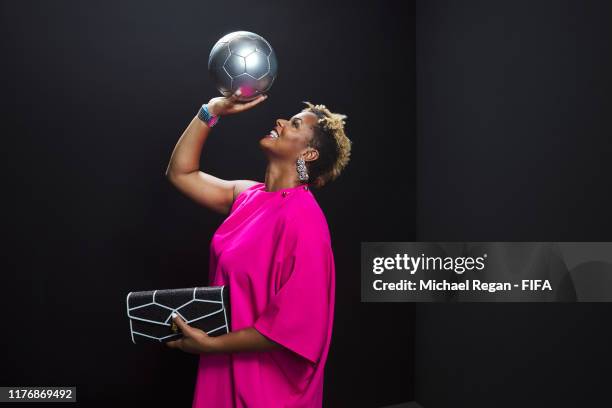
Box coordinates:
[125,285,231,344]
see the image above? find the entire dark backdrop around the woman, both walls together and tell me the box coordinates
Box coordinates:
[0,0,612,408]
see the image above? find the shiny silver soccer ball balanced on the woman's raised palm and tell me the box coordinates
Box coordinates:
[208,31,278,101]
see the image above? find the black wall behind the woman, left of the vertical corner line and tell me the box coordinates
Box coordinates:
[0,0,416,407]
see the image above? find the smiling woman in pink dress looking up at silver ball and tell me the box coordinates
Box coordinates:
[166,91,351,408]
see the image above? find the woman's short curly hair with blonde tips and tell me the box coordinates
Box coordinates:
[302,101,352,188]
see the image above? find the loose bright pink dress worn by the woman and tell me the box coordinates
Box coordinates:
[192,183,335,408]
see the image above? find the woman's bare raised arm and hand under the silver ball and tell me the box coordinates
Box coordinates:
[166,92,267,214]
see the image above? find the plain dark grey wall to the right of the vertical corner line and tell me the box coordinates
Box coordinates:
[415,0,612,408]
